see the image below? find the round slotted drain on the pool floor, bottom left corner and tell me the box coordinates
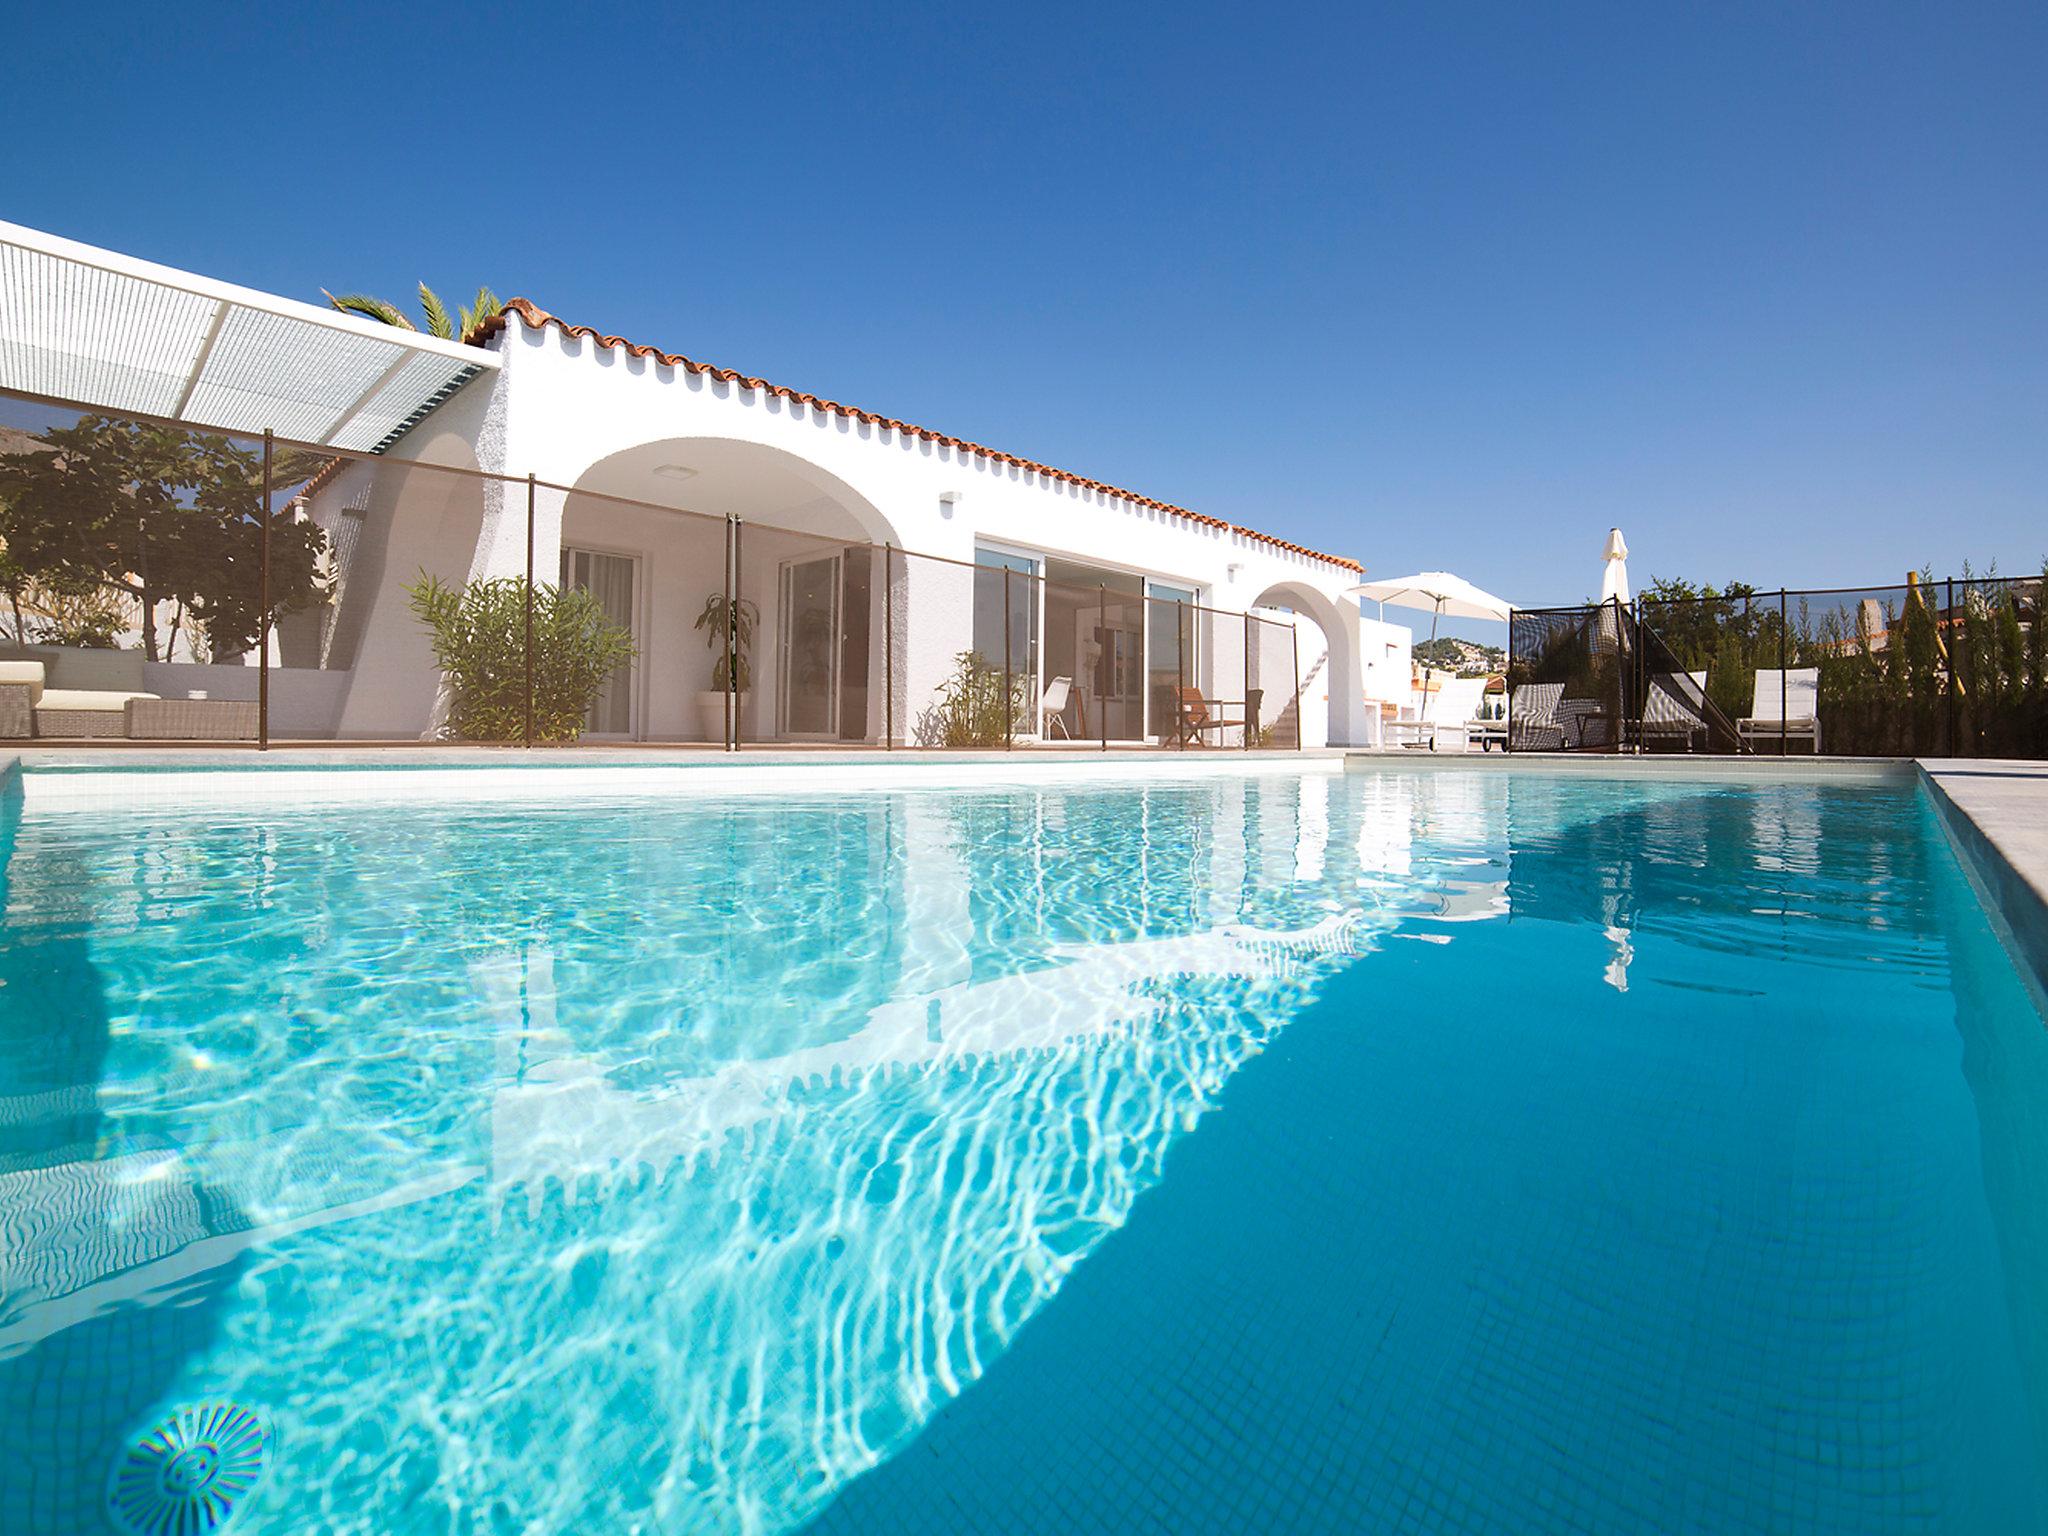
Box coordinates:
[106,1403,272,1536]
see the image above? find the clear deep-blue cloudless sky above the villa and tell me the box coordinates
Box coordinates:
[0,0,2048,604]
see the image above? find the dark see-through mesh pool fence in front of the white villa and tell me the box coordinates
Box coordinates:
[0,395,1321,752]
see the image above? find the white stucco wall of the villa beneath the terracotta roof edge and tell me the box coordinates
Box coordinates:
[303,319,1364,745]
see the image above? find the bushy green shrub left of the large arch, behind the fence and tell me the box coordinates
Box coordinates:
[406,571,637,741]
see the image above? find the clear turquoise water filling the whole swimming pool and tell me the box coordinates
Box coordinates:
[0,772,2048,1536]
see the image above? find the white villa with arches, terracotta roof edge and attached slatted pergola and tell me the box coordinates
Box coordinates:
[0,225,1407,748]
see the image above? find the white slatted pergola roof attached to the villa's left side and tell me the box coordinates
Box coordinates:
[0,221,498,453]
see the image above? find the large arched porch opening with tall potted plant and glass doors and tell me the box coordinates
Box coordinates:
[559,436,897,743]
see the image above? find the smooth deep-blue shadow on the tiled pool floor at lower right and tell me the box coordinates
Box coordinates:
[809,901,2048,1536]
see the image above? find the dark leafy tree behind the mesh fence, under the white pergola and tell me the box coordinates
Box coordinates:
[0,416,328,662]
